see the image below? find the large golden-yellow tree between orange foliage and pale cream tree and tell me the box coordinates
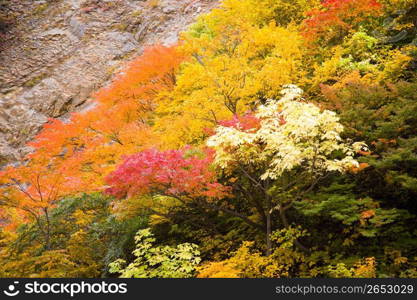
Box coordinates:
[151,1,303,148]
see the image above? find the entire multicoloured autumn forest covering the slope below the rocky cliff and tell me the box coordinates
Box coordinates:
[0,0,417,278]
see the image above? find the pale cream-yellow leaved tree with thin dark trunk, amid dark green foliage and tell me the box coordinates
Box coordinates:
[207,85,366,255]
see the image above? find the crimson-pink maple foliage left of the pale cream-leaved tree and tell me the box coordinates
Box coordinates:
[106,149,228,198]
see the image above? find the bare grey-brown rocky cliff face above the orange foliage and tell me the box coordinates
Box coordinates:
[0,0,219,165]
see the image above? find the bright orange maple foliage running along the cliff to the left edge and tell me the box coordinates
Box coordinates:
[0,45,184,231]
